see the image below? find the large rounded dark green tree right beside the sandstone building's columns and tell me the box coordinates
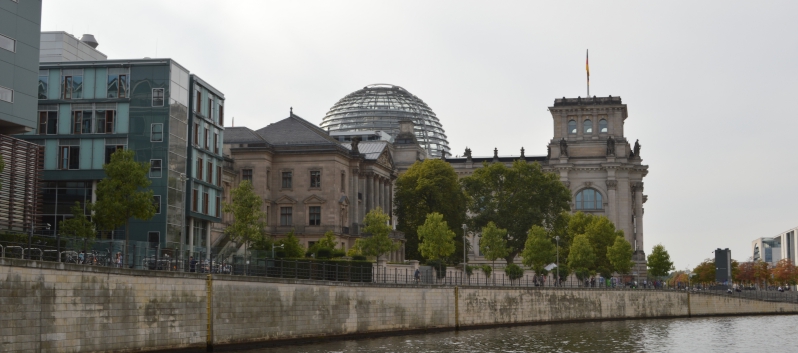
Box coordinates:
[394,159,466,261]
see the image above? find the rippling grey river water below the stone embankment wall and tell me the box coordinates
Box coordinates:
[246,315,798,353]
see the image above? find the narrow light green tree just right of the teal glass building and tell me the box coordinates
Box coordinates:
[223,180,266,253]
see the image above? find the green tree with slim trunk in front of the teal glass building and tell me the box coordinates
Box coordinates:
[92,150,155,262]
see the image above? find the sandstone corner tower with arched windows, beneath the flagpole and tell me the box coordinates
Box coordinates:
[546,96,648,262]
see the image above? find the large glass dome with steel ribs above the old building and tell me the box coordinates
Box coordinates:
[321,84,451,158]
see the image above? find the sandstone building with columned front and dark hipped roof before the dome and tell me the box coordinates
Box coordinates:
[219,112,418,261]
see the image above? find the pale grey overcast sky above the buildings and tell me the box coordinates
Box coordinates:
[42,0,798,269]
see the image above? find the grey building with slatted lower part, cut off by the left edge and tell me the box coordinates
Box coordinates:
[0,0,43,232]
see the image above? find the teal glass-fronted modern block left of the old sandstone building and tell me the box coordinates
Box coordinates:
[18,59,224,251]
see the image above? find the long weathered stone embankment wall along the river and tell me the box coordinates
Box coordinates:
[0,259,798,352]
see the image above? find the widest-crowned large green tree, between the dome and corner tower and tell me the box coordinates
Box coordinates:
[461,161,571,264]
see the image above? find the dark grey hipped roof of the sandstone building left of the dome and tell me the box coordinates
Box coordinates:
[256,113,338,146]
